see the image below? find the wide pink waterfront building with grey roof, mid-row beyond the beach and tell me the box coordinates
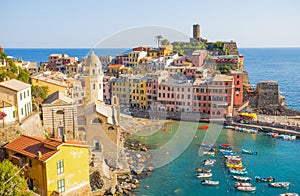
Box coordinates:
[158,77,193,112]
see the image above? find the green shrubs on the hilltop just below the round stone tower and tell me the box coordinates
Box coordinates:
[172,42,207,55]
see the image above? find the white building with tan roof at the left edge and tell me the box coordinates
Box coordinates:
[0,79,32,122]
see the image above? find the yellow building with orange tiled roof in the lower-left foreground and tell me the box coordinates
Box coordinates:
[4,135,90,195]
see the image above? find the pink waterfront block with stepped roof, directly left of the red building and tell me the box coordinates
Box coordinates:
[192,74,234,118]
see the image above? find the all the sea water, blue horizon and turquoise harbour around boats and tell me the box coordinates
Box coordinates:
[5,48,300,196]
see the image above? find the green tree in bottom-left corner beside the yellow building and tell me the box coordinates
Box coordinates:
[0,160,31,196]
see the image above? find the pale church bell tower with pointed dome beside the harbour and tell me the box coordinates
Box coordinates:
[84,50,104,103]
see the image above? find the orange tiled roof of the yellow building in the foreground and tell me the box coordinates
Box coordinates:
[4,135,83,162]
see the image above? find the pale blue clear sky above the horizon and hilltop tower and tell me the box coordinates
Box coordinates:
[0,0,300,48]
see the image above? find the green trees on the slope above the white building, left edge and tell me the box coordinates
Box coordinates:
[0,52,30,83]
